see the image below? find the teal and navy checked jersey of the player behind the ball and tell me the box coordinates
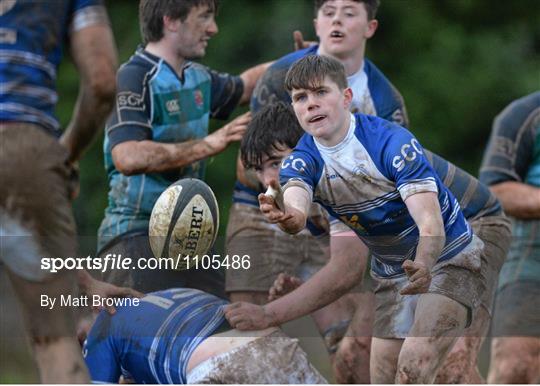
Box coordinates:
[98,49,244,249]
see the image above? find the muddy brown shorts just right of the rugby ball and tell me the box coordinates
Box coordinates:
[225,203,330,292]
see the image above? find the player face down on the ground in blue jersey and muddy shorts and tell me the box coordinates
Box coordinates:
[83,288,326,384]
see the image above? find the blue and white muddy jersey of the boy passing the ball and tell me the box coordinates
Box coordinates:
[280,114,472,277]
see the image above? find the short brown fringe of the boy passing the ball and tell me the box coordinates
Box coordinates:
[285,55,348,93]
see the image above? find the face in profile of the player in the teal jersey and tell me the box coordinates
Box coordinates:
[177,5,218,59]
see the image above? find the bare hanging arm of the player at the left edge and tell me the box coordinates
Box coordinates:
[60,23,118,162]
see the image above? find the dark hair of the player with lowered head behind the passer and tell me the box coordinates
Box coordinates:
[240,102,304,168]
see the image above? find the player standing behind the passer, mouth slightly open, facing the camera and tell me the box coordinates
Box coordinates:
[226,0,407,383]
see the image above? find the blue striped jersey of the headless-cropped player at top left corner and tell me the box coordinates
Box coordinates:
[0,0,108,136]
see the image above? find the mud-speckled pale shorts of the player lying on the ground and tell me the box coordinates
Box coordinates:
[187,331,328,384]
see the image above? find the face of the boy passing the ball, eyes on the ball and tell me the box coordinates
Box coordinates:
[291,77,352,146]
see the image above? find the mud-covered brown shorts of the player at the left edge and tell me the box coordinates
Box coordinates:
[0,123,78,338]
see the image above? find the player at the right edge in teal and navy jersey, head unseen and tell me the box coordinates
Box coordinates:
[480,91,540,383]
